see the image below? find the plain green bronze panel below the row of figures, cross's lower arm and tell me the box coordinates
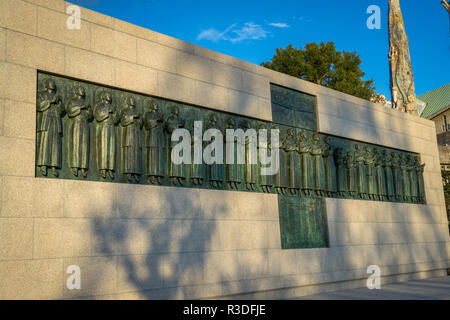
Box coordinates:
[278,196,329,249]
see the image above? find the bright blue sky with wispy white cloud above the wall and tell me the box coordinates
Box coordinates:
[71,0,450,98]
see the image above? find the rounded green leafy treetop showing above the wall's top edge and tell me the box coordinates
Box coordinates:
[261,42,375,100]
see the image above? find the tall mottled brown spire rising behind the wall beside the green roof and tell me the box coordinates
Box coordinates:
[388,0,418,115]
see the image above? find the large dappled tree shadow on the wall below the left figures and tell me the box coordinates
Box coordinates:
[91,186,229,299]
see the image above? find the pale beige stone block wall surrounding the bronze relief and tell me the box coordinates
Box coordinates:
[0,0,450,299]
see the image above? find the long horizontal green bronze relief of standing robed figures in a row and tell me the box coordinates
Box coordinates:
[36,73,425,203]
